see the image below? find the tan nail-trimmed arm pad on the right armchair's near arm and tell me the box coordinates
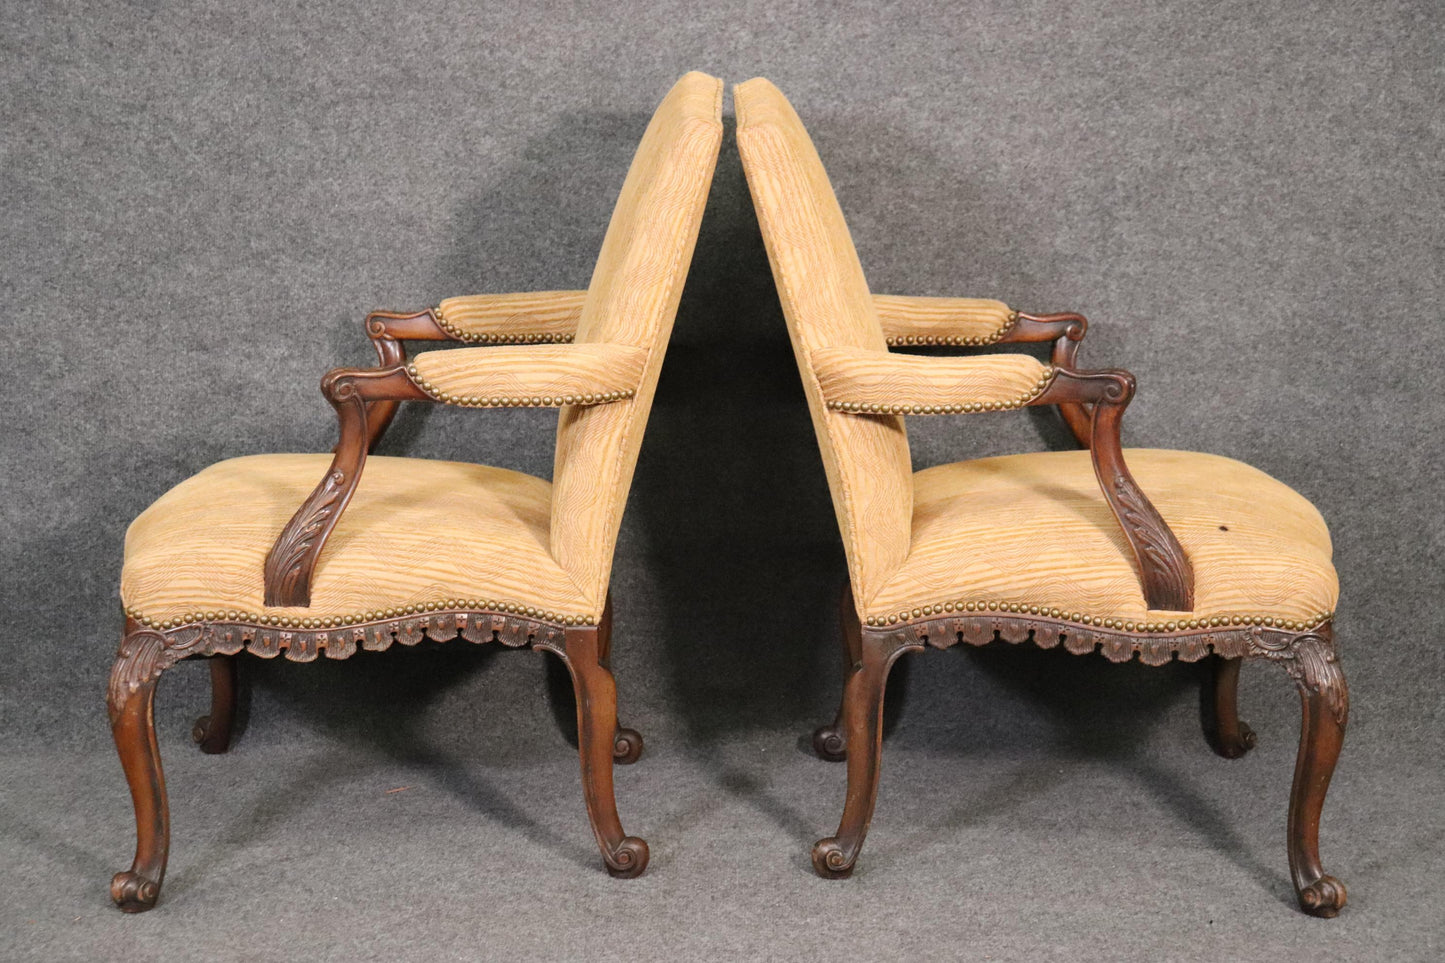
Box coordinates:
[812,348,1053,415]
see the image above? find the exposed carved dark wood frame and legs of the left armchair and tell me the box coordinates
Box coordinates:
[105,309,649,912]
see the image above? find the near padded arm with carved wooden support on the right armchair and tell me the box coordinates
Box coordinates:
[811,348,1194,612]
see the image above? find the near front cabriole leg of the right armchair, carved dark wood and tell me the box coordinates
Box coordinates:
[1254,622,1350,918]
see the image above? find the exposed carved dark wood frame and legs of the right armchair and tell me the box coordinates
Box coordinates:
[812,328,1350,917]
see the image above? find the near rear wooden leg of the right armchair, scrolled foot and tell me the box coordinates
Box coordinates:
[812,632,920,879]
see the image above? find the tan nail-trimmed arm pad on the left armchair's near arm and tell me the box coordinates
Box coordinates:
[412,344,647,408]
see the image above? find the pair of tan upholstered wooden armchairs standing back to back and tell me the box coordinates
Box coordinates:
[108,72,1348,917]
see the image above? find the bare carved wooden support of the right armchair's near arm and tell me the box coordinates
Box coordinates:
[1029,367,1194,612]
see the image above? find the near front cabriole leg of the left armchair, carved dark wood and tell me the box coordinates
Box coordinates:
[105,619,201,912]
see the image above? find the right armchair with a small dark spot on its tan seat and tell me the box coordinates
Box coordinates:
[734,78,1350,917]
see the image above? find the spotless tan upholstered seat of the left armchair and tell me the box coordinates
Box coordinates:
[120,454,600,622]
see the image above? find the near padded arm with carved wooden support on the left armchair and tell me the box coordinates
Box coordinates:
[264,344,646,607]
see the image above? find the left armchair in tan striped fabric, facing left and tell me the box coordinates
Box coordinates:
[108,74,723,912]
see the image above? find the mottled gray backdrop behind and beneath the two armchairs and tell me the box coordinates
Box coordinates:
[0,0,1445,960]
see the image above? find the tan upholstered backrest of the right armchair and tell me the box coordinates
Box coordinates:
[733,78,913,604]
